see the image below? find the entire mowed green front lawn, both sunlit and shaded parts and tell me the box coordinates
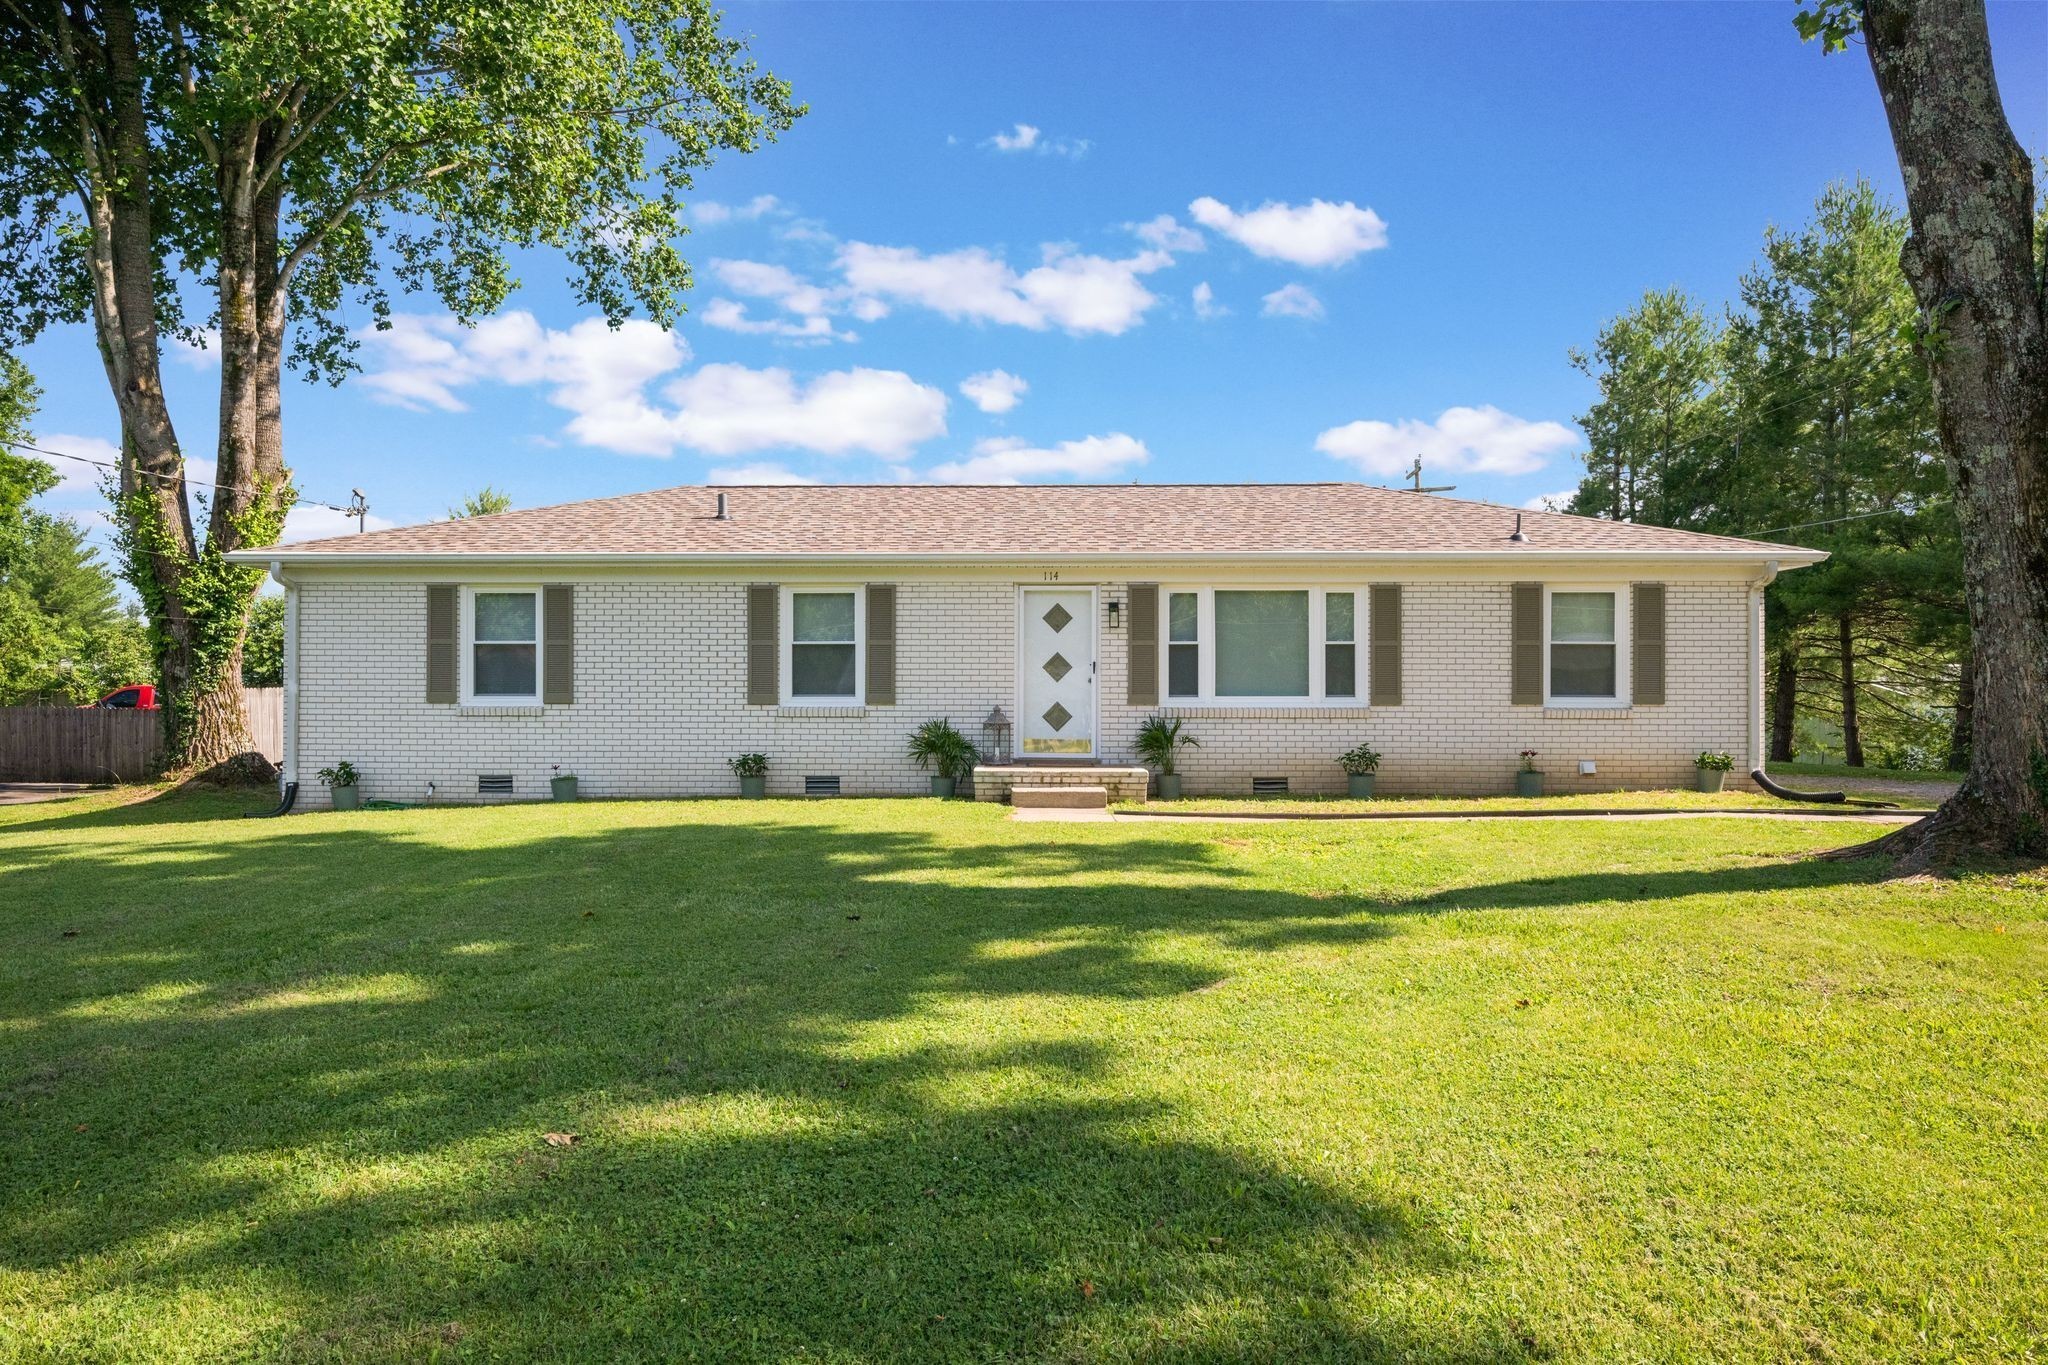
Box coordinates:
[0,785,2048,1361]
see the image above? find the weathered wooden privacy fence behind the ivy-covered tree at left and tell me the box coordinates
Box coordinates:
[0,688,285,782]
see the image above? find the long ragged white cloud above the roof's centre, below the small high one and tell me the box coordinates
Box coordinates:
[840,241,1174,336]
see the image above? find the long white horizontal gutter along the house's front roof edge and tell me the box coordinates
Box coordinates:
[227,544,1827,577]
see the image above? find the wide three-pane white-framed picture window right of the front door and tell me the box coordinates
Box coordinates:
[1159,585,1366,706]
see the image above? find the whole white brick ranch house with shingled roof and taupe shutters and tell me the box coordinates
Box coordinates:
[233,483,1823,804]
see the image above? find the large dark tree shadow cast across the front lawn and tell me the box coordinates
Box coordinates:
[0,806,1864,1361]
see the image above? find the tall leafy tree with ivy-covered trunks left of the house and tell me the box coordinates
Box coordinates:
[0,0,803,765]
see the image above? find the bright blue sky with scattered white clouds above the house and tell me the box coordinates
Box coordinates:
[25,0,2048,534]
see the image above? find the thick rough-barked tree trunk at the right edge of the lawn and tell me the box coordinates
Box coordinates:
[1862,0,2048,866]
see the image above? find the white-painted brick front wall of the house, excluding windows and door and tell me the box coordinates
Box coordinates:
[297,577,1757,806]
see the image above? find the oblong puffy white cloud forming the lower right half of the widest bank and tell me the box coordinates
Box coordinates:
[664,364,946,456]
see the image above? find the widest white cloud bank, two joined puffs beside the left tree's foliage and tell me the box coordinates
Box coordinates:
[362,313,946,456]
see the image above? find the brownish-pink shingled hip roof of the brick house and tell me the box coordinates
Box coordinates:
[251,483,1819,561]
